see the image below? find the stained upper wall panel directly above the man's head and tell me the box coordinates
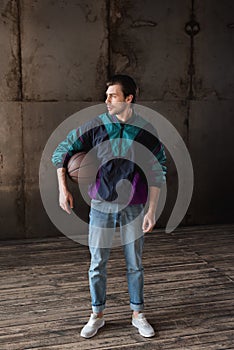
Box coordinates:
[110,0,190,100]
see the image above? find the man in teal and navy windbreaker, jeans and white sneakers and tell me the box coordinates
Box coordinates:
[52,75,166,338]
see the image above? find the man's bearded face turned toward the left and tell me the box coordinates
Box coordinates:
[105,84,131,115]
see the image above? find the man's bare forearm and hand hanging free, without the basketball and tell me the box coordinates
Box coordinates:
[142,186,160,233]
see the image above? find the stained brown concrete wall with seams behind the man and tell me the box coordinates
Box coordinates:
[0,0,234,239]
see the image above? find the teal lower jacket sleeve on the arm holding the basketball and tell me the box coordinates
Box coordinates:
[51,128,89,168]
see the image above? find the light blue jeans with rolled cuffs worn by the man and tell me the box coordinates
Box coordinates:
[89,203,144,313]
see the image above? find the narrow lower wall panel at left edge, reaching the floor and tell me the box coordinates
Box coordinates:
[0,102,25,239]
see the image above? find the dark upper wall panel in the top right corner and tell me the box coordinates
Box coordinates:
[194,0,234,99]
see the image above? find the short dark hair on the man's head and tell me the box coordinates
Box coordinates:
[106,74,138,103]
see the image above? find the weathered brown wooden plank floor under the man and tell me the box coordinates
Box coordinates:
[0,225,234,350]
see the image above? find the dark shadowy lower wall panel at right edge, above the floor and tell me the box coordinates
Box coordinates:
[189,101,234,224]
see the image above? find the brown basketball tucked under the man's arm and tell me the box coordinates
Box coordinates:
[67,152,98,185]
